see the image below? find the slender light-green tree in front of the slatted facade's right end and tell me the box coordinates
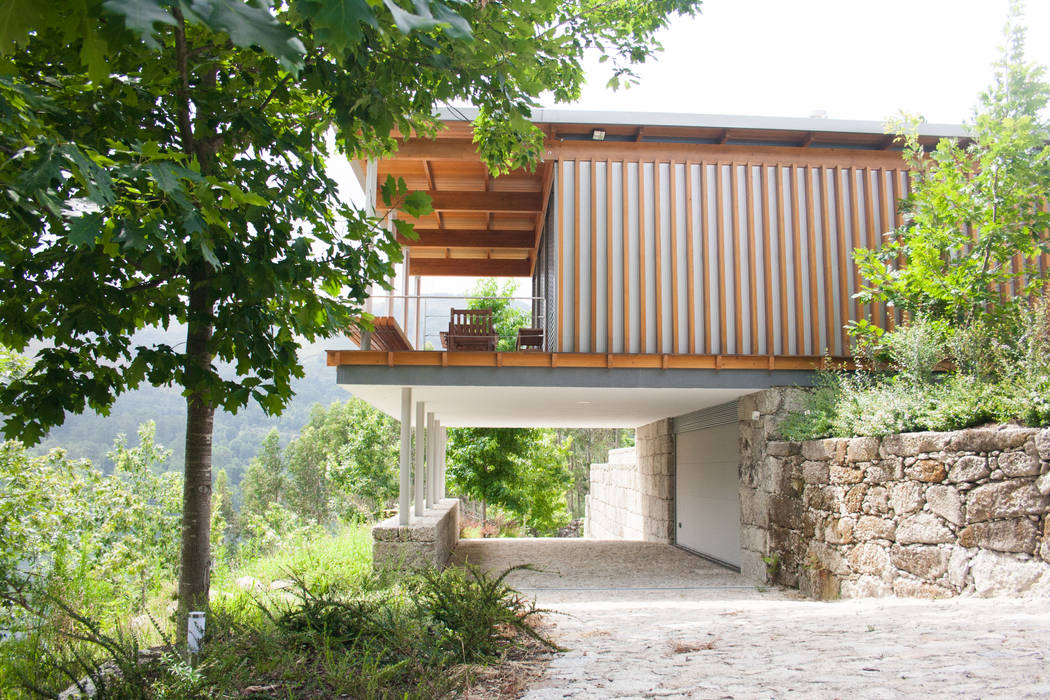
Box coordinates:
[856,1,1050,333]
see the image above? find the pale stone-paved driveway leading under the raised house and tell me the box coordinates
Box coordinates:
[454,539,1050,700]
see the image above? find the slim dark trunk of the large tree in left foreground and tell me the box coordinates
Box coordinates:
[176,283,215,643]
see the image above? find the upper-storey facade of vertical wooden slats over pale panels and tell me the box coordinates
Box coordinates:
[550,149,906,356]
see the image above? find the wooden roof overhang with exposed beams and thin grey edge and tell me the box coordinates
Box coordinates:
[354,109,966,277]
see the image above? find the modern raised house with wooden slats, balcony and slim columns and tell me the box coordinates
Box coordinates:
[329,110,999,575]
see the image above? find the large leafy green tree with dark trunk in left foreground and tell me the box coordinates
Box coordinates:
[0,0,697,635]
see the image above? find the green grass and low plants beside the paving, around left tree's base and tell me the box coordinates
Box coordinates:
[0,526,553,700]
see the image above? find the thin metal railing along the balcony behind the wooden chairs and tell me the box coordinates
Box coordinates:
[365,295,551,351]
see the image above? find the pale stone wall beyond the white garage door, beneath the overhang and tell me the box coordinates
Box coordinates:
[584,420,674,543]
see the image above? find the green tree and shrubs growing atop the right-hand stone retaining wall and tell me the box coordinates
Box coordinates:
[780,3,1050,440]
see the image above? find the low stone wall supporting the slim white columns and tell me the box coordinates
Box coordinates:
[372,499,459,569]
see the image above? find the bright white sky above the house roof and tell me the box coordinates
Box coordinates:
[333,0,1050,293]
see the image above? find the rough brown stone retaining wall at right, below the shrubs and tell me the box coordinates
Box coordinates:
[741,426,1050,598]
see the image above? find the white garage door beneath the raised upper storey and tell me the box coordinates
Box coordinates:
[673,401,740,570]
